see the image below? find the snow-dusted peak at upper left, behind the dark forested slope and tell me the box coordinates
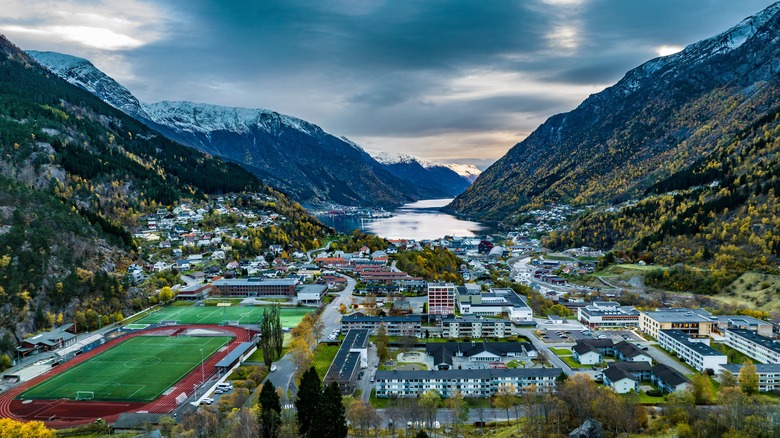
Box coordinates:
[27,50,148,119]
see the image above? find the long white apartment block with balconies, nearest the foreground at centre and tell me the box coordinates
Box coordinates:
[374,368,562,398]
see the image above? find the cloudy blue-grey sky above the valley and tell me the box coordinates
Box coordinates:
[0,0,773,168]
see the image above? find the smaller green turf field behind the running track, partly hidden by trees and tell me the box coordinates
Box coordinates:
[135,306,312,328]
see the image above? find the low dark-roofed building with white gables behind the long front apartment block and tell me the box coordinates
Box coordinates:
[426,342,538,370]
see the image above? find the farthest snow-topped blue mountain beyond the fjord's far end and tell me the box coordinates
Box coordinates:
[373,152,479,198]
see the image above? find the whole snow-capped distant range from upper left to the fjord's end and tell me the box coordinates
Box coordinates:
[28,51,478,207]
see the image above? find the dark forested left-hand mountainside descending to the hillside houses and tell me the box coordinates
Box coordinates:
[0,36,326,352]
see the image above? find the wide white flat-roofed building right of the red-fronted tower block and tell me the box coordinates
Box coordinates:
[455,286,533,324]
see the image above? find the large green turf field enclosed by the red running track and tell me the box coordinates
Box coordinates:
[18,336,232,401]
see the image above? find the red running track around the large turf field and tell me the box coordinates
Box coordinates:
[0,325,250,428]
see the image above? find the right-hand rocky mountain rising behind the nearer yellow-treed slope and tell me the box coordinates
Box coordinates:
[449,4,780,222]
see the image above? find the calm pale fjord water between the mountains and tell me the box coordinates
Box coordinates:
[318,199,495,240]
